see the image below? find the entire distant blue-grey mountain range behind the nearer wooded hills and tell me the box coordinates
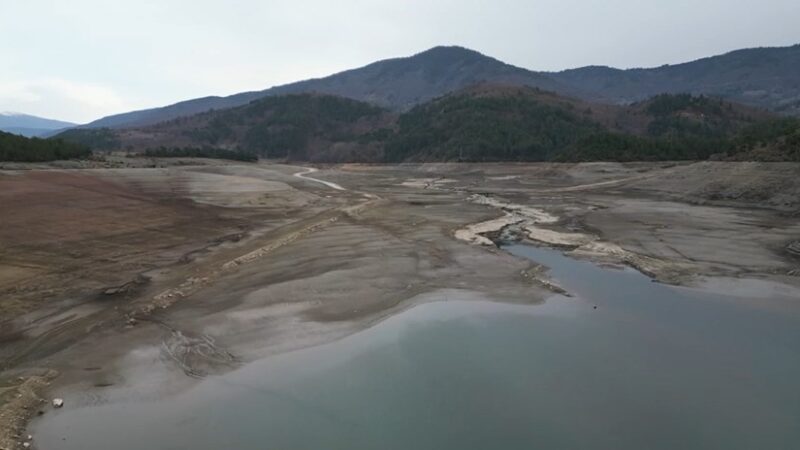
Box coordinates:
[79,45,800,128]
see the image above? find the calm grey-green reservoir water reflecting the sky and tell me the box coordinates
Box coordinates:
[34,245,800,450]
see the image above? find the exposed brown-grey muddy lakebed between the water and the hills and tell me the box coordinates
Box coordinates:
[0,160,800,449]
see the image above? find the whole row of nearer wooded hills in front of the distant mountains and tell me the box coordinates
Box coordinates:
[59,83,800,162]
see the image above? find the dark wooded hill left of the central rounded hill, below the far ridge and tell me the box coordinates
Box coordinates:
[82,94,395,161]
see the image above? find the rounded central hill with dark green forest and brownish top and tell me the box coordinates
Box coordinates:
[386,85,605,161]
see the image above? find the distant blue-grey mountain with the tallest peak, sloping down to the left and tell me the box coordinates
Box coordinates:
[79,47,580,128]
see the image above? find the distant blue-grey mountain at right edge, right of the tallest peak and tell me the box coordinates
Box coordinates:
[547,45,800,115]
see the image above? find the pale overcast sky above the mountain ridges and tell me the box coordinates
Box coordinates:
[0,0,800,122]
